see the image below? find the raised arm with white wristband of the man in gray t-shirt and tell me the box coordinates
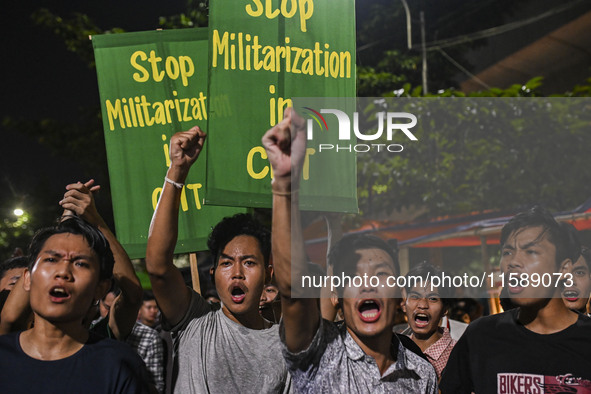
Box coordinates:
[146,126,205,326]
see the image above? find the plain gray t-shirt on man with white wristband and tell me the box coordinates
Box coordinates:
[165,291,289,393]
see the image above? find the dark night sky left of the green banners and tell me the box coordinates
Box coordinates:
[0,0,186,222]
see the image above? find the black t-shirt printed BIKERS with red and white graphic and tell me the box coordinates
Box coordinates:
[439,308,591,394]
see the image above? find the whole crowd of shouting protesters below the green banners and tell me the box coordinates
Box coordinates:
[0,110,591,394]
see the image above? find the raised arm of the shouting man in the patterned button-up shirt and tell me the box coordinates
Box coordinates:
[263,108,320,352]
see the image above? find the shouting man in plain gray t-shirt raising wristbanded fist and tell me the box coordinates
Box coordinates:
[146,127,290,394]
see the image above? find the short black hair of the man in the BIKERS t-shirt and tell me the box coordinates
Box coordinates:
[501,205,581,266]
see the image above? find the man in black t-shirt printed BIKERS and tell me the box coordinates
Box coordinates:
[440,207,591,394]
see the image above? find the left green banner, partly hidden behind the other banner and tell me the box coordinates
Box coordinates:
[92,29,245,258]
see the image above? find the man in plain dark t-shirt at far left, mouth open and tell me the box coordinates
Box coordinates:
[0,217,149,394]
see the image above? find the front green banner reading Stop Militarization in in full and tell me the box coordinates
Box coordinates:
[205,0,358,212]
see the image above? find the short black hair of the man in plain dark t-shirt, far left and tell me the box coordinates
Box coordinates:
[29,216,115,280]
